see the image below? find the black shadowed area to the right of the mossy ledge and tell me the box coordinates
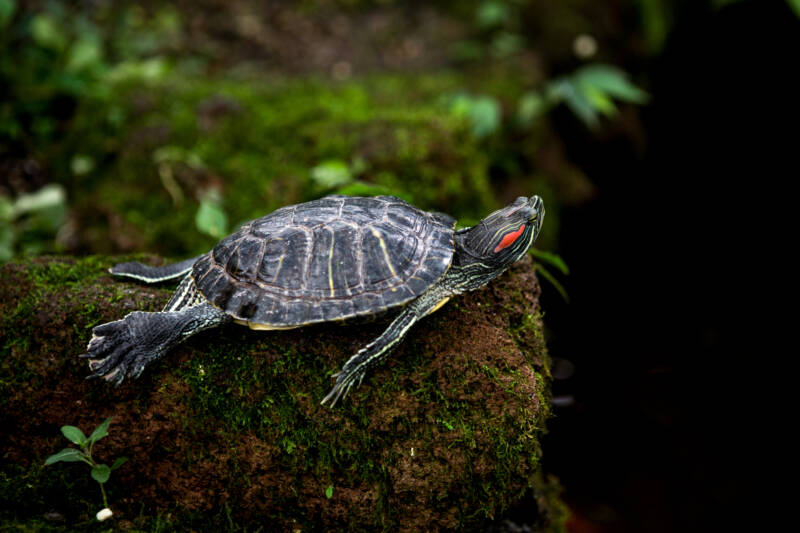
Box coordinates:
[544,2,800,531]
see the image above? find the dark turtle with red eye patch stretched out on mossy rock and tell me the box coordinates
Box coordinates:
[80,195,545,407]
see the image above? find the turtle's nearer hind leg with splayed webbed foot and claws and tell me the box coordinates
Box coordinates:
[80,303,231,386]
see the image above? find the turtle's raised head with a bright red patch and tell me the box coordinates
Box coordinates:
[464,196,544,269]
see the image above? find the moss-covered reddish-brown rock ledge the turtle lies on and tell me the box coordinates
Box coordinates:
[0,257,563,531]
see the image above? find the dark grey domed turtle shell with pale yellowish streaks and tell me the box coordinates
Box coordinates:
[192,196,455,329]
